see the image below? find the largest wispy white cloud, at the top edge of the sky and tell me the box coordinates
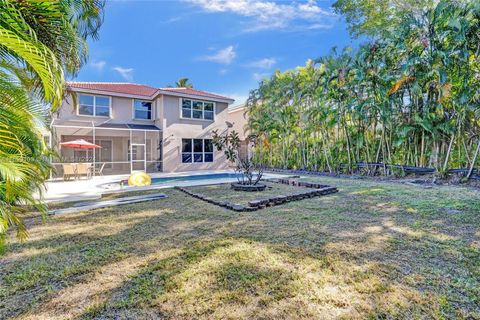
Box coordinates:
[187,0,335,32]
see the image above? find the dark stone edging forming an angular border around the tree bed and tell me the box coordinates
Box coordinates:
[175,179,338,212]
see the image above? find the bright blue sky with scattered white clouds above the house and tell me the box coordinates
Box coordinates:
[75,0,352,103]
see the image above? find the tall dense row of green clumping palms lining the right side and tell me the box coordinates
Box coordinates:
[247,1,480,173]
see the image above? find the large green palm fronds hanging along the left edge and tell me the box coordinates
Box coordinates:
[0,0,104,249]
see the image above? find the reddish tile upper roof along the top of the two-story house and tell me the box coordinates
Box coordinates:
[67,81,233,101]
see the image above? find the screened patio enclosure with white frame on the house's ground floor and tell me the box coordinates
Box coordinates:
[49,120,162,177]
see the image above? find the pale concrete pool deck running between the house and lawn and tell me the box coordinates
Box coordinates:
[37,170,288,202]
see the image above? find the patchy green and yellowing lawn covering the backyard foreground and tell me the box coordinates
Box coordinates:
[0,178,480,319]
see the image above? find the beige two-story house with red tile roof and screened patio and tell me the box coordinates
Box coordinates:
[50,82,234,175]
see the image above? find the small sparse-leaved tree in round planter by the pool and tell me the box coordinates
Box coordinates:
[212,130,264,185]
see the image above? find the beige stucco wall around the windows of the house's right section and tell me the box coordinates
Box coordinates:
[160,96,228,172]
